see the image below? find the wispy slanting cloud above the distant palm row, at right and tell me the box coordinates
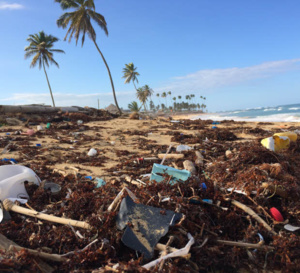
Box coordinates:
[156,59,300,94]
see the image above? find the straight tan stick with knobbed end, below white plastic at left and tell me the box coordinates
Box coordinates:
[3,199,92,229]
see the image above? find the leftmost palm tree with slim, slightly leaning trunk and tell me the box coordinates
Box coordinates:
[25,31,65,107]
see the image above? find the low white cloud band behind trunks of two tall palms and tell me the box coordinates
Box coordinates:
[0,91,135,108]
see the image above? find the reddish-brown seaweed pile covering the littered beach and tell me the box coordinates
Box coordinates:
[0,116,300,272]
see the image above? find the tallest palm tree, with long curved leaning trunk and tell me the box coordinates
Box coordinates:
[55,0,122,114]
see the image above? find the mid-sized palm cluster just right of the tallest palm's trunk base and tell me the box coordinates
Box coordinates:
[123,63,154,112]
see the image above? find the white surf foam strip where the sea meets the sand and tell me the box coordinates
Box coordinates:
[192,113,300,122]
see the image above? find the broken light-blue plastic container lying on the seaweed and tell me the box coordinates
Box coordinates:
[150,163,191,185]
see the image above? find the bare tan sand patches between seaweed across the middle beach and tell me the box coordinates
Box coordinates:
[0,114,300,178]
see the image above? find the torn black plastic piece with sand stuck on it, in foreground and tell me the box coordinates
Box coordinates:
[117,196,182,259]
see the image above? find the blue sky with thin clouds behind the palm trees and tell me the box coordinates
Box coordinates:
[0,0,300,112]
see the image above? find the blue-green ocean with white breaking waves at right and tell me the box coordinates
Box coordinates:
[192,103,300,122]
